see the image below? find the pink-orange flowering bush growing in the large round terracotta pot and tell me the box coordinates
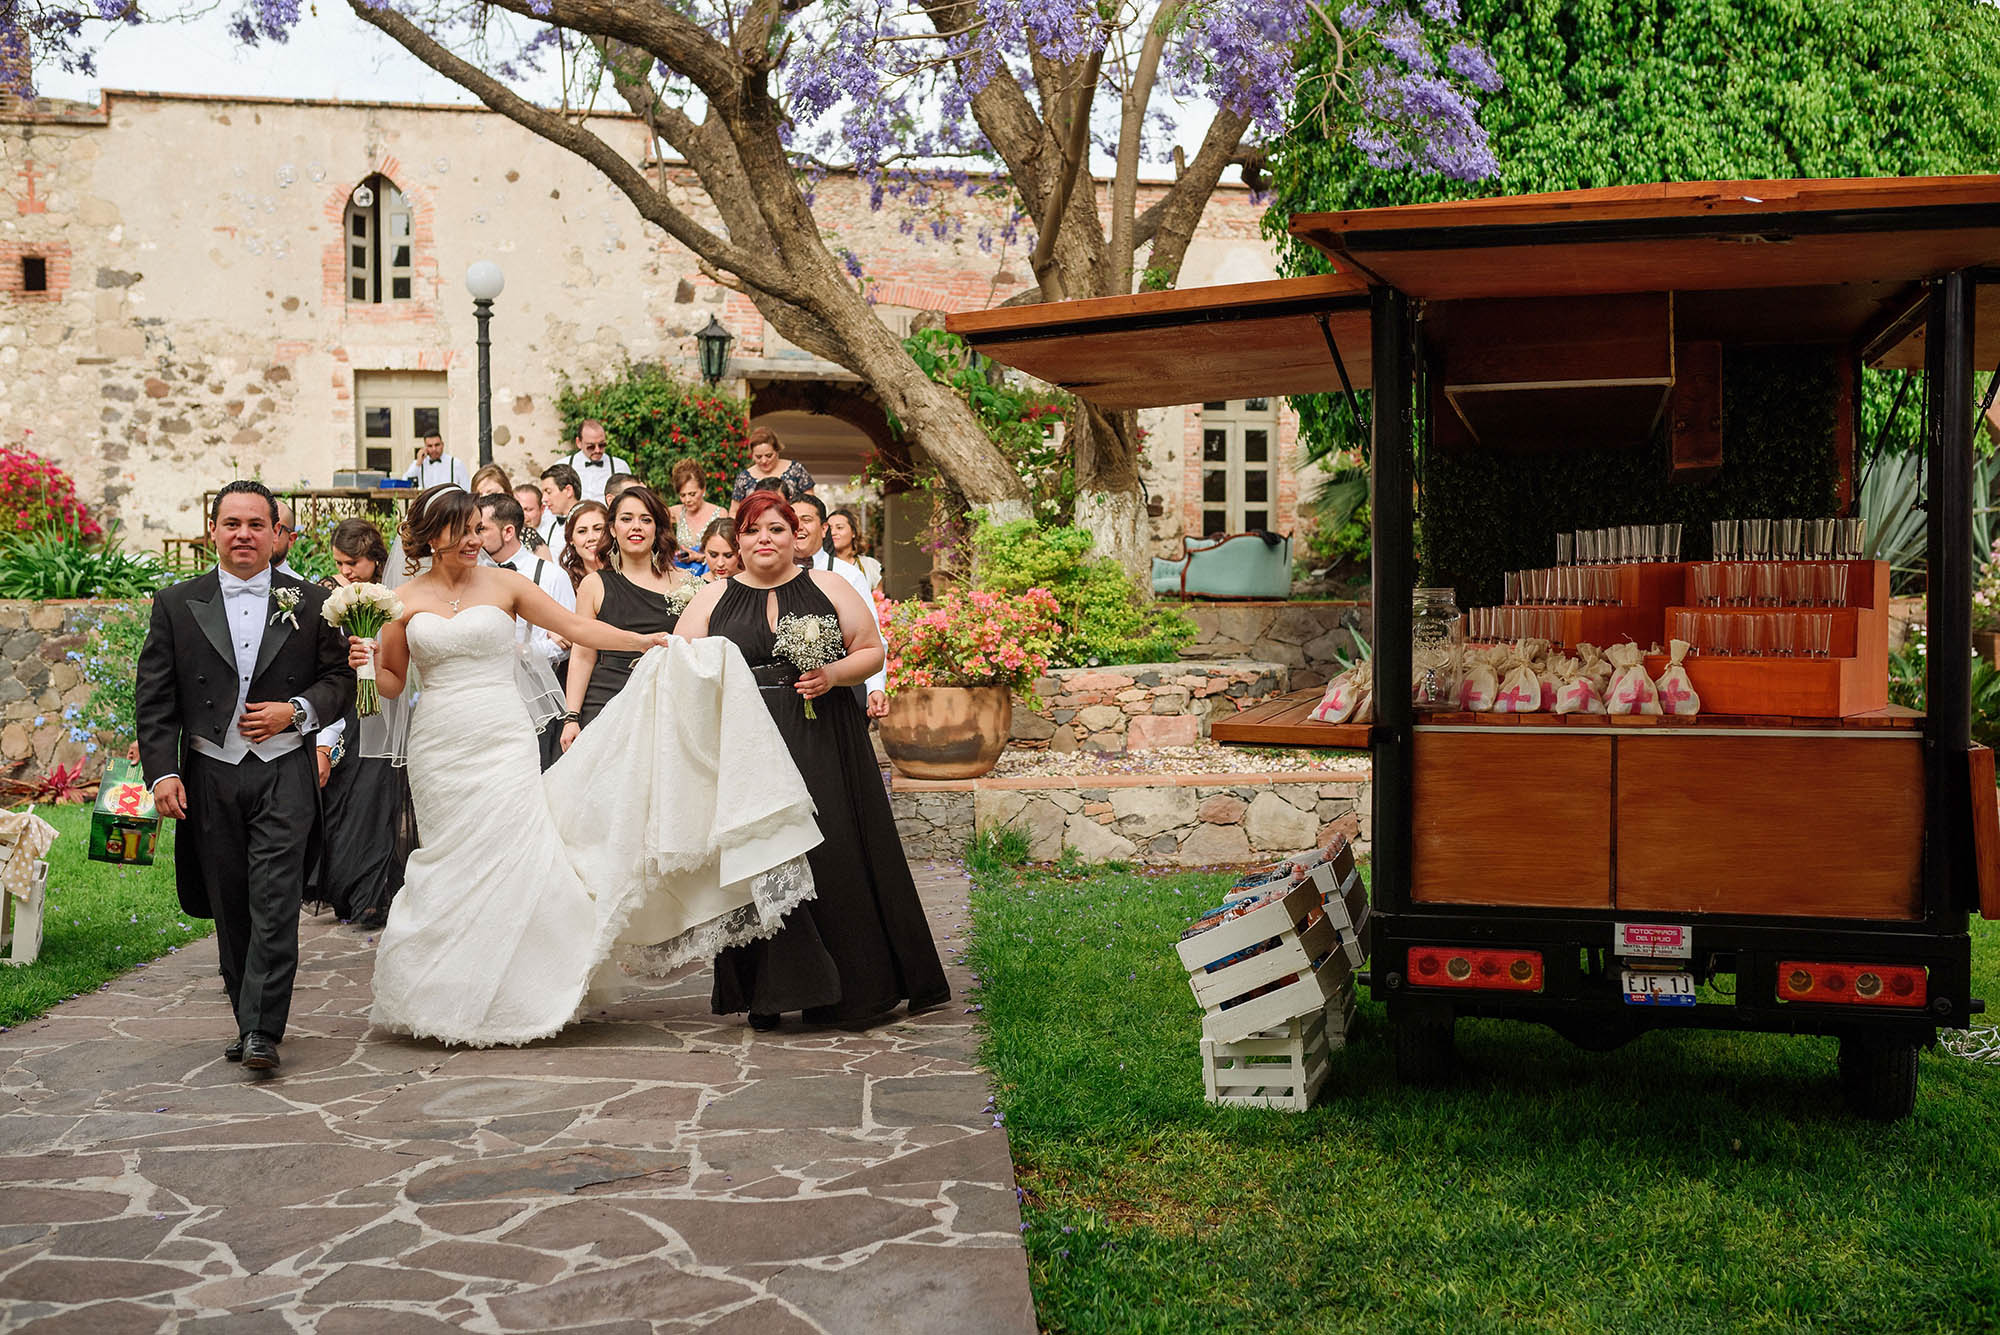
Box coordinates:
[876,590,1062,695]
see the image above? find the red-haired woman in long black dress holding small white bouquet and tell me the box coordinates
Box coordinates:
[680,492,952,1029]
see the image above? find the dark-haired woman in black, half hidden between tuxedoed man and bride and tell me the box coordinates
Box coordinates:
[310,520,416,929]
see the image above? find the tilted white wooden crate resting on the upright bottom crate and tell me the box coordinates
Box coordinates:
[1176,881,1354,1043]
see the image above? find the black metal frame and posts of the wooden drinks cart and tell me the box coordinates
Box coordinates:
[1370,267,1990,1043]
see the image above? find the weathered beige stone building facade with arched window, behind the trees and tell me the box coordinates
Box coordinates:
[0,92,1298,579]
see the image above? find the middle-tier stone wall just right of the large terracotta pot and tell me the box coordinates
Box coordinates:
[1012,660,1286,751]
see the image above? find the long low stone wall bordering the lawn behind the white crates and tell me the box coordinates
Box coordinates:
[890,771,1374,867]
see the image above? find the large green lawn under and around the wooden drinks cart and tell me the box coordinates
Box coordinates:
[970,865,2000,1335]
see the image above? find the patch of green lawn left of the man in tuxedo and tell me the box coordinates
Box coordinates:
[0,805,214,1025]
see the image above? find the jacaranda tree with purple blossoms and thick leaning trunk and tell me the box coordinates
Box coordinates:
[0,0,1498,562]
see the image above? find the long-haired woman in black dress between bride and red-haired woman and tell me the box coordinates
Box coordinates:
[562,486,692,751]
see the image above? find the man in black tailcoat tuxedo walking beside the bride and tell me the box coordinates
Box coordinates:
[134,482,354,1071]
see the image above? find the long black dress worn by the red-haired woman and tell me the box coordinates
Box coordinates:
[708,572,952,1023]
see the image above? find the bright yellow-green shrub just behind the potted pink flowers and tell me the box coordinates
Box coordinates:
[972,520,1196,668]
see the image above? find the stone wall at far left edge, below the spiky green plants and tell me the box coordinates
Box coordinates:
[0,600,108,777]
